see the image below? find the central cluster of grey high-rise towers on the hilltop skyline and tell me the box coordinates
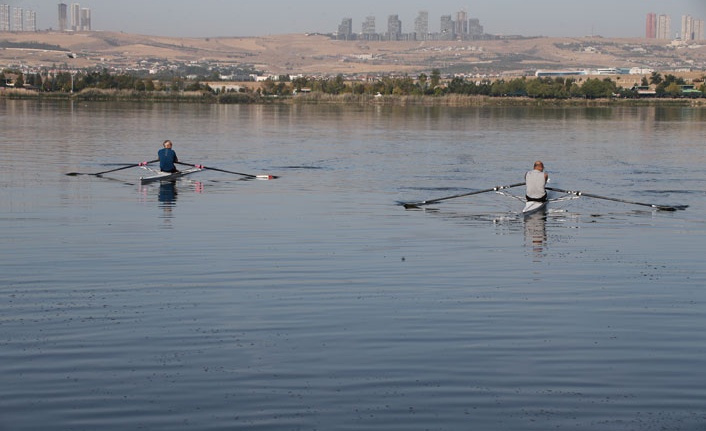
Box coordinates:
[335,11,488,40]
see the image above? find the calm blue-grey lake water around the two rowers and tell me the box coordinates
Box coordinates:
[0,100,706,431]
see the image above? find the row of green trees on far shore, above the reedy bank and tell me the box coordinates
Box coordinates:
[0,69,706,103]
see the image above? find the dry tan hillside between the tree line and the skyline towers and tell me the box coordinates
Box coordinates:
[0,32,706,75]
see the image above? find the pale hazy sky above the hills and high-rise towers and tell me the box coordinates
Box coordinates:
[8,0,706,37]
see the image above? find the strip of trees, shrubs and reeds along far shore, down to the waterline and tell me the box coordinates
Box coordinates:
[0,69,706,106]
